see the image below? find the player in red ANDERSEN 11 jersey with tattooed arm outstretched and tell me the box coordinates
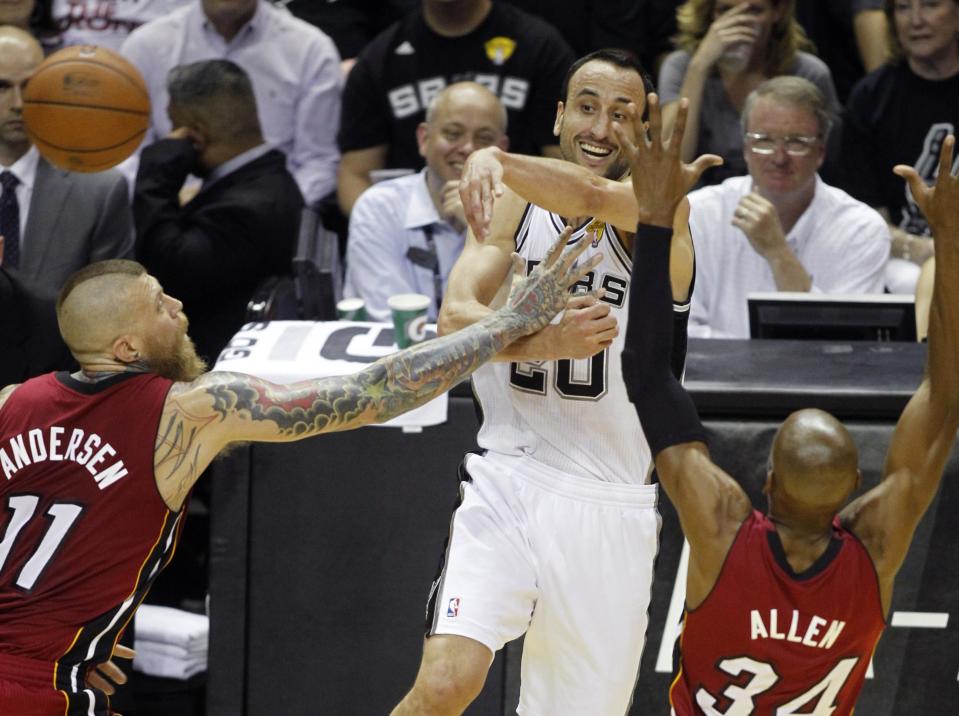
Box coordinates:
[0,228,594,716]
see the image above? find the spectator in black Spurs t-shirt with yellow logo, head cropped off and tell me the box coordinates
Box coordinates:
[337,0,573,213]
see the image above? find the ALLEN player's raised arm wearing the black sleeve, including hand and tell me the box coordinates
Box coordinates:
[617,95,750,607]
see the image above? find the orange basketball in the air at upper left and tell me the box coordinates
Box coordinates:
[23,45,150,172]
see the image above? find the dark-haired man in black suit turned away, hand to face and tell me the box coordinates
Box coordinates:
[133,60,303,365]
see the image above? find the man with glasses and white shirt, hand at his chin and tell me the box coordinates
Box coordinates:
[689,76,890,338]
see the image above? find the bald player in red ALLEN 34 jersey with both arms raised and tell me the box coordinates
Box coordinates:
[620,99,959,716]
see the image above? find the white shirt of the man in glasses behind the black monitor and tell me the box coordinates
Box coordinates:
[689,176,892,338]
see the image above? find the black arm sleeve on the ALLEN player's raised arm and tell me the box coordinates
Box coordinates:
[622,224,706,457]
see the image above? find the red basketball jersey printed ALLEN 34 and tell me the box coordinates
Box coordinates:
[669,510,885,716]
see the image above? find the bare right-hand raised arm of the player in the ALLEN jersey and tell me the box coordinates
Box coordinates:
[841,135,959,609]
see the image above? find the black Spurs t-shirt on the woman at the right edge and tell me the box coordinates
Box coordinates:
[841,63,959,235]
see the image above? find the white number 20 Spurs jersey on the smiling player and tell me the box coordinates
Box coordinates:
[473,204,689,484]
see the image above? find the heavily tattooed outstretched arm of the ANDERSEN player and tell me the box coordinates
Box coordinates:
[154,232,602,510]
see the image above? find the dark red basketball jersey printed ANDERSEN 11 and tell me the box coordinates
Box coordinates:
[0,373,185,714]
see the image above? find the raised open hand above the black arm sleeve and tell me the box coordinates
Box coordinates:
[613,92,723,227]
